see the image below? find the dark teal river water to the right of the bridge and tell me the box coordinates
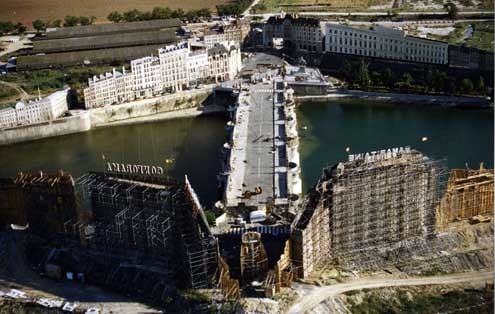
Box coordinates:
[297,101,494,191]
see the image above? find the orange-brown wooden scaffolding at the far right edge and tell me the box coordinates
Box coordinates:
[437,164,494,231]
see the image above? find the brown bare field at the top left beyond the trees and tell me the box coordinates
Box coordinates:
[0,0,229,28]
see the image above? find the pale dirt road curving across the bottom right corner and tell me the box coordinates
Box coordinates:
[288,271,493,314]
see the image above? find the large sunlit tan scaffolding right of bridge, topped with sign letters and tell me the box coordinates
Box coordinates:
[291,147,446,277]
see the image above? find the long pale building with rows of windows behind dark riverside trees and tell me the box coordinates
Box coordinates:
[324,23,449,65]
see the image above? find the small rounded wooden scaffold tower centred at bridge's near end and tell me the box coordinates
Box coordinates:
[240,231,268,283]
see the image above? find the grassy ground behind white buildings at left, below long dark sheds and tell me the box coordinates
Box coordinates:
[0,66,116,100]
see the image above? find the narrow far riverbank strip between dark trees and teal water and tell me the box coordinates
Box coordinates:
[295,89,493,108]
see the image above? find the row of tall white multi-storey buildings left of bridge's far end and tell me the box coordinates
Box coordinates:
[84,42,241,109]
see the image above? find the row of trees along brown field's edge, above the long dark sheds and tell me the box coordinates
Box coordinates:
[107,7,211,23]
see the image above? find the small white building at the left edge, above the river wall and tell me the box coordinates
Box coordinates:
[0,89,69,128]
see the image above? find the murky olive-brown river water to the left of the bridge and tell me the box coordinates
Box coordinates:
[0,116,226,207]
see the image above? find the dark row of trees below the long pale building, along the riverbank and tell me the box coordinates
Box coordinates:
[338,60,488,96]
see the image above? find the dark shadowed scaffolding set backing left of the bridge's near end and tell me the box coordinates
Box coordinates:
[65,173,218,288]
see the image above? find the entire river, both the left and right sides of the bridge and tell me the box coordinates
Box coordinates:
[0,102,493,207]
